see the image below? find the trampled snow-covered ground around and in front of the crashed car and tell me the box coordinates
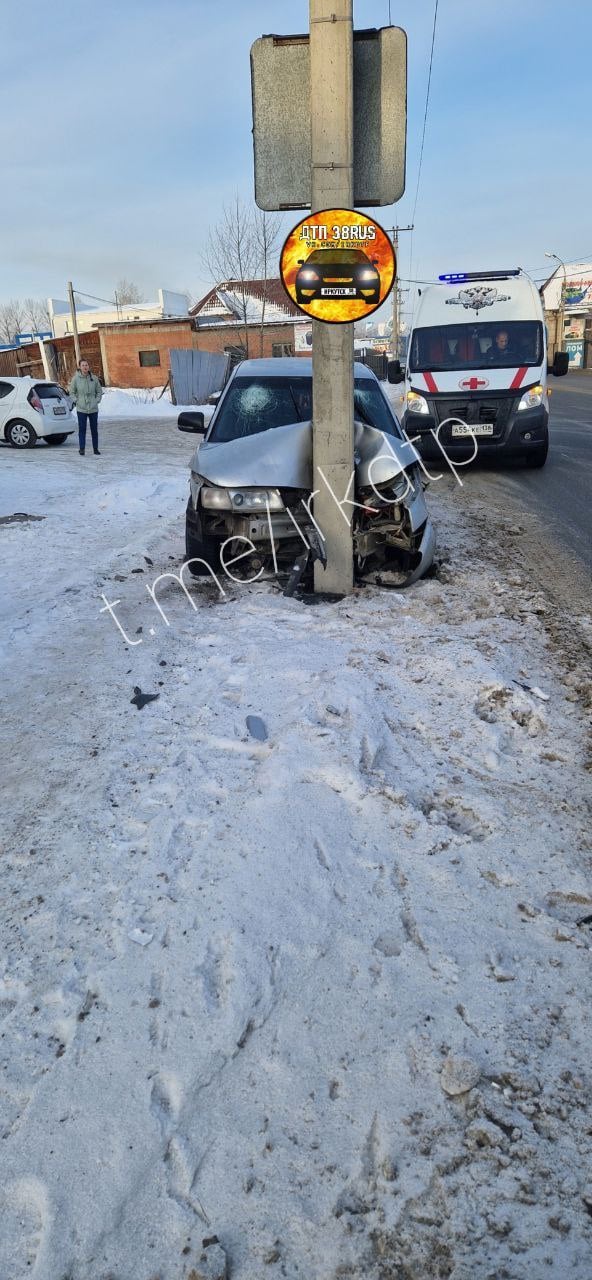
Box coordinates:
[0,419,592,1280]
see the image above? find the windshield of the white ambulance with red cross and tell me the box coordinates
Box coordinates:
[409,320,543,372]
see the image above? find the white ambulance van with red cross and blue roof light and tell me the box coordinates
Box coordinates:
[388,269,569,467]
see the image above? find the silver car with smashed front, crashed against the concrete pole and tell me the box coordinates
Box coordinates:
[178,357,434,586]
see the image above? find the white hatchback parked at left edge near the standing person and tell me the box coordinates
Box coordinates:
[0,374,77,449]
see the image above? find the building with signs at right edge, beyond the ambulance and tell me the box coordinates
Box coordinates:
[541,262,592,369]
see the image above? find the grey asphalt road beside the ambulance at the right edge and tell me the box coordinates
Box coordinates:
[463,372,592,577]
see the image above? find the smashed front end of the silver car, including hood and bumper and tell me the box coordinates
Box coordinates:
[187,422,436,586]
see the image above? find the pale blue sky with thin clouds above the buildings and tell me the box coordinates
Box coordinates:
[0,0,592,320]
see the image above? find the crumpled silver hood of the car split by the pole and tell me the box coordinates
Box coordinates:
[192,421,419,490]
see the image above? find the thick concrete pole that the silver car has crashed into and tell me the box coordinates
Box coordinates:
[310,0,354,595]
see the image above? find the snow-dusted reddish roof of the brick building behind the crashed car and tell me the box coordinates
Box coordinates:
[190,279,302,325]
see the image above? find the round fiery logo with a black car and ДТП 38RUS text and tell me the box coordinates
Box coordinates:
[279,209,396,324]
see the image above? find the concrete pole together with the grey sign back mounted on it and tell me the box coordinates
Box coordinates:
[251,15,407,596]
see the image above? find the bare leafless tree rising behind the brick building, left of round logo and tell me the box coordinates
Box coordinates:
[204,196,260,357]
